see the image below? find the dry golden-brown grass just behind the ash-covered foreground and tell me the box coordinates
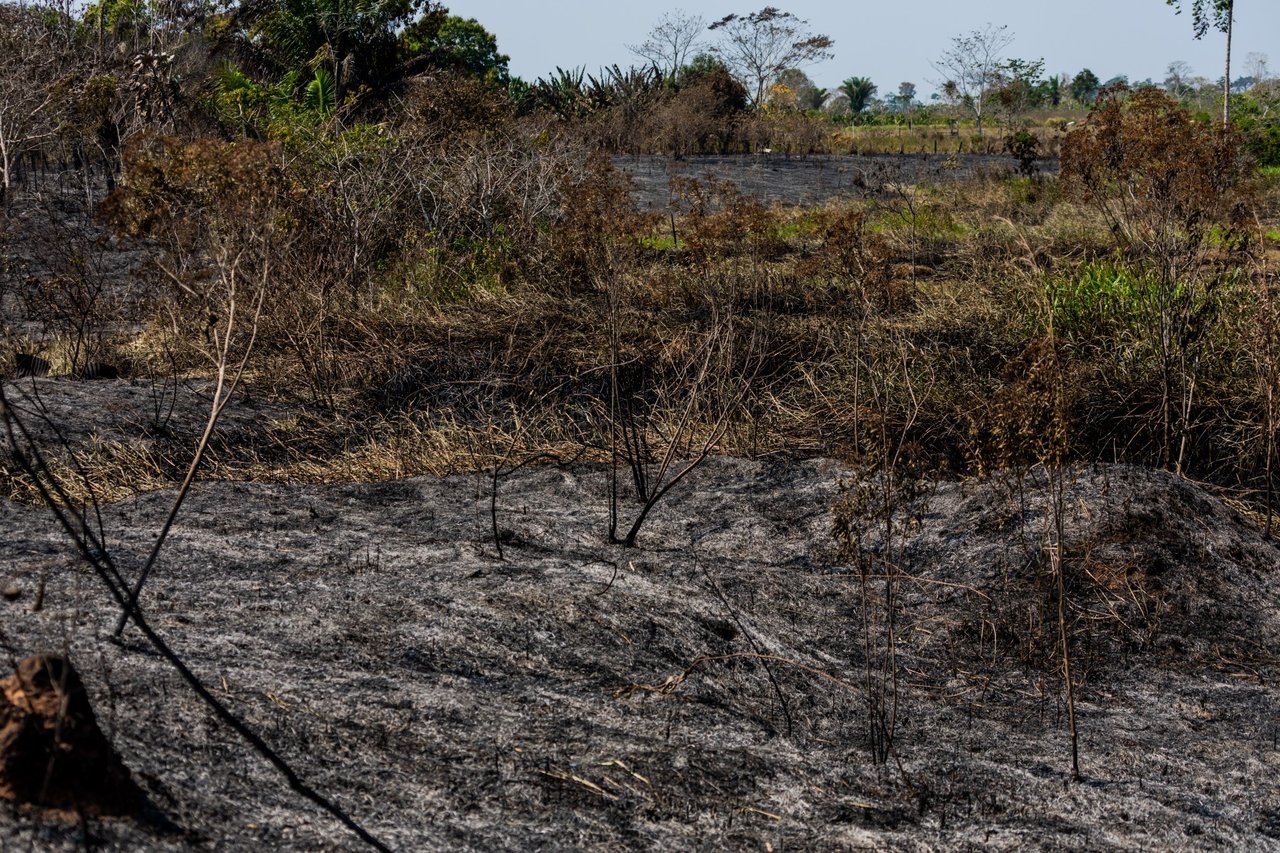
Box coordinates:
[8,90,1280,512]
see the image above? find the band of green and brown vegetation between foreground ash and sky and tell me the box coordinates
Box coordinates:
[0,0,1280,504]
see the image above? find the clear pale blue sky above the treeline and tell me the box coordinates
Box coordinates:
[444,0,1280,97]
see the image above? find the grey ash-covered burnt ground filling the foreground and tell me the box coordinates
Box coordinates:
[0,384,1280,850]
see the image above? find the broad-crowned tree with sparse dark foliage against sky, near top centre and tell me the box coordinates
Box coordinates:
[708,6,836,109]
